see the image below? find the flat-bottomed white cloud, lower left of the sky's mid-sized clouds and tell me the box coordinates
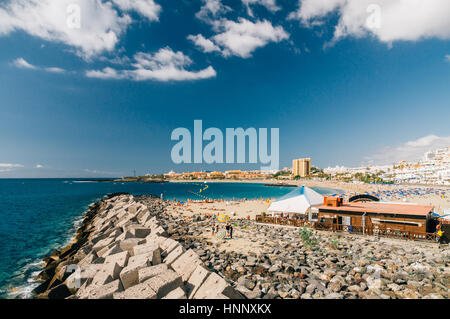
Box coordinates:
[86,47,216,82]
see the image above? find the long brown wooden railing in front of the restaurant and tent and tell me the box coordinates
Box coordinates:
[256,215,436,241]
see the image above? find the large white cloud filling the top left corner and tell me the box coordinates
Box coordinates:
[0,0,136,58]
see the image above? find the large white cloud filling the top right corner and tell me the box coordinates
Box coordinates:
[289,0,450,43]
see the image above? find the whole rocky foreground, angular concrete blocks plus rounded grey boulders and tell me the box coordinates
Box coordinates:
[30,194,450,299]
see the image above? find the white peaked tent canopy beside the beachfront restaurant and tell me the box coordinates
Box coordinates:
[268,186,323,214]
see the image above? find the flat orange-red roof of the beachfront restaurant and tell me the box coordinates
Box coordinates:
[319,202,434,216]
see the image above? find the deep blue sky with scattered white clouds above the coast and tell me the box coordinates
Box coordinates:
[0,0,450,177]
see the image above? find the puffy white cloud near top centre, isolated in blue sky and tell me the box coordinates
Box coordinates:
[192,18,289,58]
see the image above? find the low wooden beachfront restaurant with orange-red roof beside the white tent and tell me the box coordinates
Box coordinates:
[318,199,436,236]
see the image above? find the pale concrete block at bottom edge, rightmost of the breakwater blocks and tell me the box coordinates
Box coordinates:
[193,272,244,299]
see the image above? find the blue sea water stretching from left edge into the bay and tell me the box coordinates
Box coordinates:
[0,179,335,298]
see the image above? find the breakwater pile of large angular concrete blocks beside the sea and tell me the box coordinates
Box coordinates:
[34,194,244,299]
